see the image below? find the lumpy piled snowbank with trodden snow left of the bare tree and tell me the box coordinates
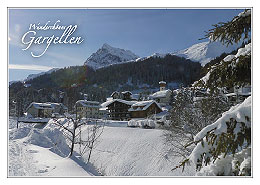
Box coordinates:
[8,118,99,176]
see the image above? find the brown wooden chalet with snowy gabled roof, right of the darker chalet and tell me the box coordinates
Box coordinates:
[128,100,162,118]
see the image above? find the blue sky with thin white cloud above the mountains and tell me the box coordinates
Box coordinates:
[9,9,242,81]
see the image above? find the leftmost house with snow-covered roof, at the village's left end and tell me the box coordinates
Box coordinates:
[26,102,68,118]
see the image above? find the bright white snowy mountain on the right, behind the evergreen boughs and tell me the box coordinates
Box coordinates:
[171,41,241,66]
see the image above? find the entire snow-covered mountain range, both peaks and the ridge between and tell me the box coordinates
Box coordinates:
[84,41,241,69]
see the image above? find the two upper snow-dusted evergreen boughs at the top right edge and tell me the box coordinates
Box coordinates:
[194,10,251,90]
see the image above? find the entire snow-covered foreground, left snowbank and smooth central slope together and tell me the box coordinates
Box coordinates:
[9,119,195,176]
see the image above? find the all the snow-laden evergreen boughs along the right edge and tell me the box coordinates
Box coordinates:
[174,10,252,176]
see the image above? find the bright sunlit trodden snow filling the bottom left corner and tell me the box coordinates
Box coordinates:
[9,140,92,177]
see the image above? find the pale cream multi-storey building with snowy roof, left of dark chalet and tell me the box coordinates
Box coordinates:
[75,100,101,118]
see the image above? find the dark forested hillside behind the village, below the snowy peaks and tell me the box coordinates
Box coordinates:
[9,55,201,110]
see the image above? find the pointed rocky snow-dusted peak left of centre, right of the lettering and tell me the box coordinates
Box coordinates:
[84,44,138,69]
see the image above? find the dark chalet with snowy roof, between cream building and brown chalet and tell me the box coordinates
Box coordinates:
[102,99,137,120]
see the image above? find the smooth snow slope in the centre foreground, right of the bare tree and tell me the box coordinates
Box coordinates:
[77,126,195,176]
